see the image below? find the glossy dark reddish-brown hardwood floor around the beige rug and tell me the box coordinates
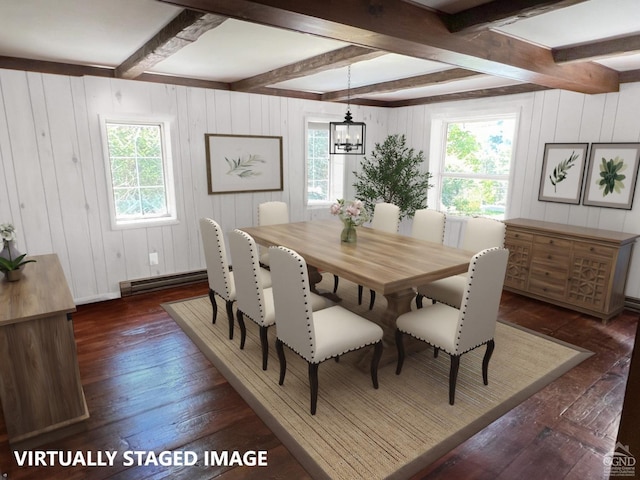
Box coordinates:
[0,283,640,480]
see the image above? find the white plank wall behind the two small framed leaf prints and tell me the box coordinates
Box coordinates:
[388,83,640,299]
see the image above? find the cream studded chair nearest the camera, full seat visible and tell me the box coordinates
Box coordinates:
[269,246,382,415]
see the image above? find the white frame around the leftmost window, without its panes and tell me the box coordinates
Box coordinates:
[100,114,179,230]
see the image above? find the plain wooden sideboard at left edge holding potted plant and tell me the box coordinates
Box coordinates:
[0,254,89,448]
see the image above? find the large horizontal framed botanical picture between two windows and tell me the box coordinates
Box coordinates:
[205,133,283,195]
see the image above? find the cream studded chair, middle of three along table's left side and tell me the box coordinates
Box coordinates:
[229,229,331,370]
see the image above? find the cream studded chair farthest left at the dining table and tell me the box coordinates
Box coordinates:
[200,218,271,339]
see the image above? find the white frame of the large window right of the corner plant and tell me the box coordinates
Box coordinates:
[428,108,521,218]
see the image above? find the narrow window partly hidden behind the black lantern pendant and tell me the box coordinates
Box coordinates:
[307,121,345,205]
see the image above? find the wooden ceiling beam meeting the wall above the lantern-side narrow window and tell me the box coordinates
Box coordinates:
[321,68,486,102]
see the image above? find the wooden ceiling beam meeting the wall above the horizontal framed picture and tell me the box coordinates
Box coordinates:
[231,45,387,92]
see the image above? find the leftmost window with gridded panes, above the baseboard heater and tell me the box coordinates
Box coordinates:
[103,120,176,228]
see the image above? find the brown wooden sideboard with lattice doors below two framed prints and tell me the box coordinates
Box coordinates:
[504,218,639,322]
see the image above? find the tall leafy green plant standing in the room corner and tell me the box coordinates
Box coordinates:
[353,134,433,219]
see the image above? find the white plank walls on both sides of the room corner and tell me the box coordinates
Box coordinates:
[0,69,640,303]
